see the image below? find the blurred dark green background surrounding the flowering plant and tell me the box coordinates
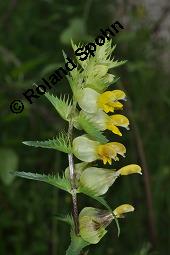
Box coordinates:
[0,0,170,255]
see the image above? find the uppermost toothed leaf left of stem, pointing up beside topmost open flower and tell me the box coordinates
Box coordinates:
[45,93,72,121]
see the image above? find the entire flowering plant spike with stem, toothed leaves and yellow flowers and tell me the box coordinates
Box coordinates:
[17,40,141,255]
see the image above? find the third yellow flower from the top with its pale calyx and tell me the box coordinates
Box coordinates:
[73,135,126,164]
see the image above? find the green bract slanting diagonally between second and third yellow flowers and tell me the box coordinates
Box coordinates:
[77,112,108,144]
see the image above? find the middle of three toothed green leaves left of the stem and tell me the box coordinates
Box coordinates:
[23,132,72,153]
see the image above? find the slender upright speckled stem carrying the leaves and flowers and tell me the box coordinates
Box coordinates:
[68,112,79,235]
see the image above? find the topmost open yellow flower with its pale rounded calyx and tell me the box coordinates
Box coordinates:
[77,88,126,113]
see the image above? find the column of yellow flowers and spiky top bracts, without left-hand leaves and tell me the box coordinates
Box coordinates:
[71,41,141,244]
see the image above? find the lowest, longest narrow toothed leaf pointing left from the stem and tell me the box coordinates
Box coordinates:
[14,172,71,193]
